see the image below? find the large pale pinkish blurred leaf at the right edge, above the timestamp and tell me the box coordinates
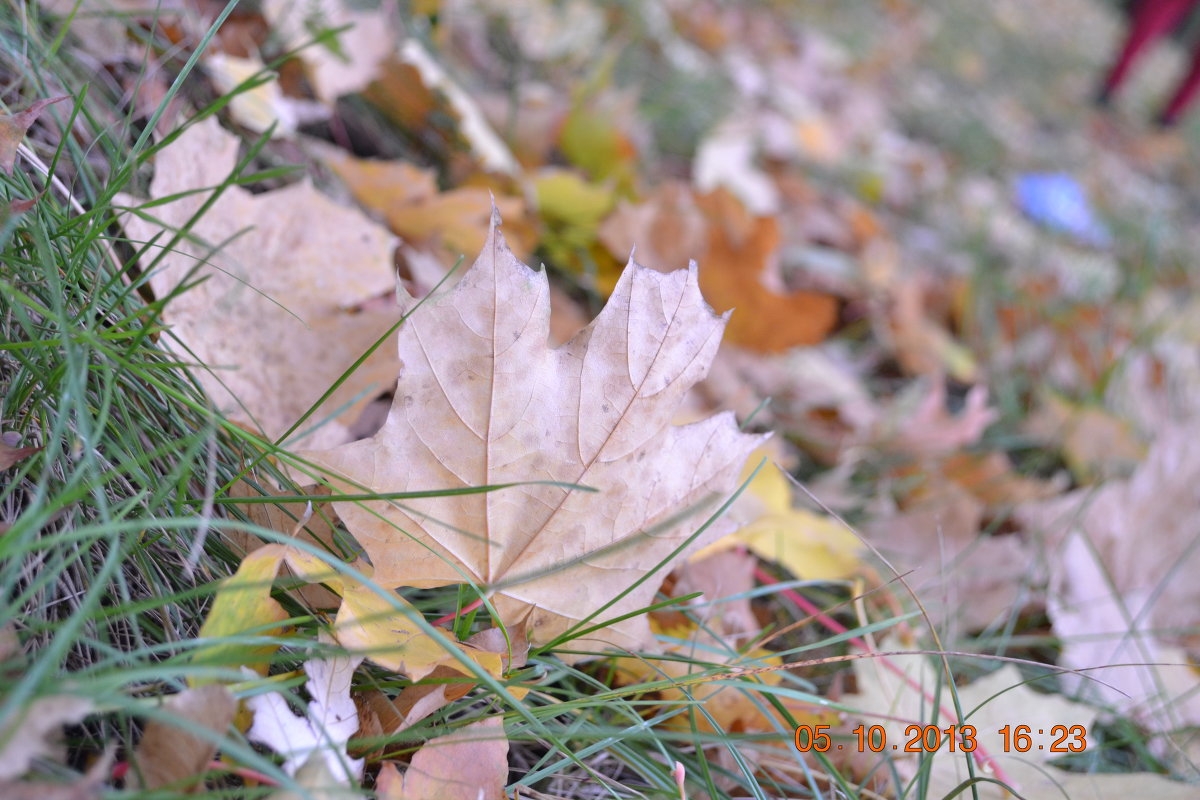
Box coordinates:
[1018,423,1200,730]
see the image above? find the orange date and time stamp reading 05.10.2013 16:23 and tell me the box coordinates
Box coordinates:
[796,723,1087,753]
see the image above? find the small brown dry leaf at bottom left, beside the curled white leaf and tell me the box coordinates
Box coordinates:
[130,684,238,793]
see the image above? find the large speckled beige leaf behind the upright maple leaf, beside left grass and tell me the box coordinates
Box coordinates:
[118,119,400,446]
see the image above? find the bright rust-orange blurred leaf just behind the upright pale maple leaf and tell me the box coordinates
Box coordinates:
[697,190,838,353]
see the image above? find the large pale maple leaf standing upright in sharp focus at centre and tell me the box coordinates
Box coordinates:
[308,216,762,651]
